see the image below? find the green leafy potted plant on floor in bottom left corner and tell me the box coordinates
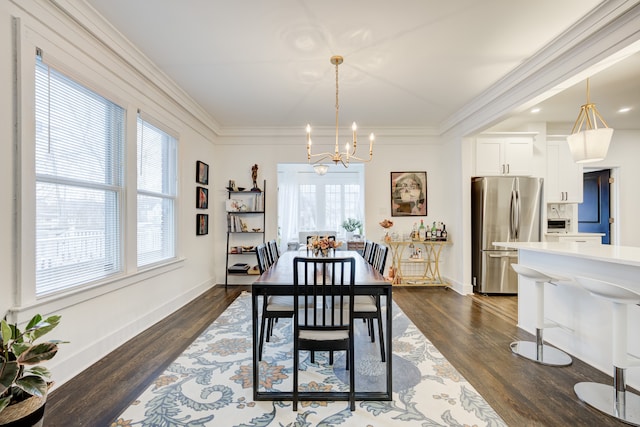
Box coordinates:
[0,314,62,426]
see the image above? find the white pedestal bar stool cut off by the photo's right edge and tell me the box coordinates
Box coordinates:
[573,277,640,426]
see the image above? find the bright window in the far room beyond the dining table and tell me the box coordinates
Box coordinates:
[278,164,364,243]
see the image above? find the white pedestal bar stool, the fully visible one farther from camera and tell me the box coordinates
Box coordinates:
[511,264,572,366]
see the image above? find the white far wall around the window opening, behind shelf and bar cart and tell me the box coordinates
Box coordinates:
[214,132,461,290]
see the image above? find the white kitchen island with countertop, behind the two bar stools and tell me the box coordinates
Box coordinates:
[494,242,640,389]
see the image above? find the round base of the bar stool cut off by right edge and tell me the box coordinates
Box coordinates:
[573,382,640,426]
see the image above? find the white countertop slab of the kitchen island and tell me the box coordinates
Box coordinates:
[493,242,640,266]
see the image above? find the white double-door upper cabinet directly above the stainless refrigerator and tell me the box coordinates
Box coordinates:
[475,132,536,176]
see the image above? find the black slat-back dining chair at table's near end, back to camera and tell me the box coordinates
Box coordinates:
[293,257,355,411]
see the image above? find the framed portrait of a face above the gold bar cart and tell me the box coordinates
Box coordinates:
[391,172,427,216]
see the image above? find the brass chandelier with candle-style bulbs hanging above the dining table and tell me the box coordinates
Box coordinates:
[307,56,375,171]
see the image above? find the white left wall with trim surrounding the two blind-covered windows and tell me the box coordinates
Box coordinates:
[0,0,220,385]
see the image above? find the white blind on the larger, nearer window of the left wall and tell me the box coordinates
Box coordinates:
[35,56,125,296]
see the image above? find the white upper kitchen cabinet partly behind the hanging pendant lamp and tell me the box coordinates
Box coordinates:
[545,138,583,203]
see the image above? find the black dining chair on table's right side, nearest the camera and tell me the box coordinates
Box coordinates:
[353,242,389,362]
